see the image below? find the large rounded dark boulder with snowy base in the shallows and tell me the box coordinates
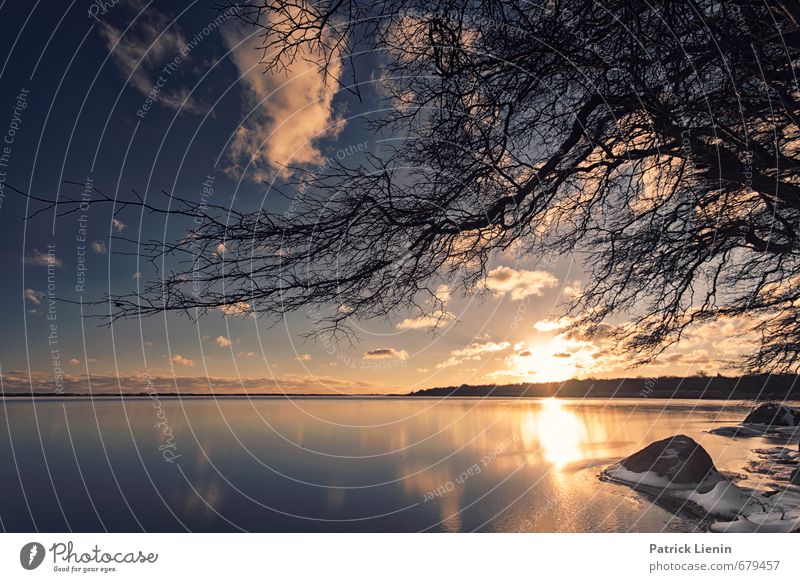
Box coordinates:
[612,435,722,487]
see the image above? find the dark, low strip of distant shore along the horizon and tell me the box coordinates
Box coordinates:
[0,374,800,400]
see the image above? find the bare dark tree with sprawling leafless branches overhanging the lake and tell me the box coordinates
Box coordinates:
[37,0,800,370]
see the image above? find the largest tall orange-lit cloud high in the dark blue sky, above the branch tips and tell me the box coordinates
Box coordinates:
[222,17,344,180]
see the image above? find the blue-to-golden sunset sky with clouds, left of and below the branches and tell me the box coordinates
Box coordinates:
[0,0,742,394]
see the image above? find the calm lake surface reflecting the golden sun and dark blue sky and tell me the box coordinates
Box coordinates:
[0,398,784,532]
